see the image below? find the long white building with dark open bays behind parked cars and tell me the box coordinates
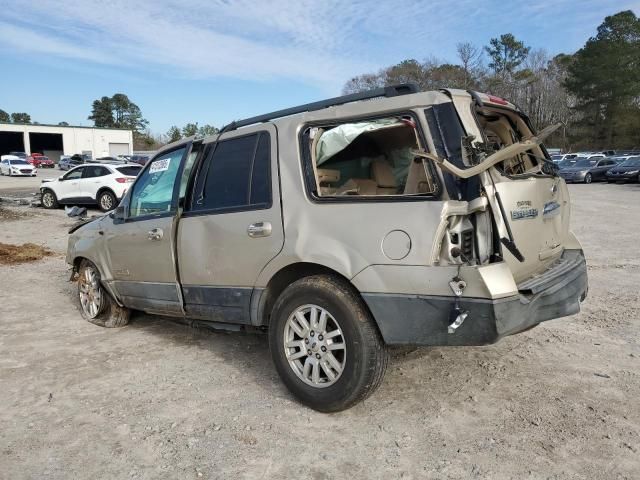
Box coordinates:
[0,123,133,162]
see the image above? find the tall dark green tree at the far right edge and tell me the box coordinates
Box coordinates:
[565,10,640,148]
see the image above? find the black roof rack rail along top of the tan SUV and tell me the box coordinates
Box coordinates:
[221,83,420,132]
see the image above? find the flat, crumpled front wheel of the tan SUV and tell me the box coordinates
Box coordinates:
[78,260,131,328]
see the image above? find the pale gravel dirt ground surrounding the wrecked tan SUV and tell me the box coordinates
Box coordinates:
[0,179,640,480]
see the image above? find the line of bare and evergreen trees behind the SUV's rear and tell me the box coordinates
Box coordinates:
[343,10,640,150]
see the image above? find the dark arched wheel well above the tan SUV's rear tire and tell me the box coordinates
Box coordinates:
[257,262,366,325]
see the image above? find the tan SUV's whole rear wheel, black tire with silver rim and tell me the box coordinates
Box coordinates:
[269,275,389,412]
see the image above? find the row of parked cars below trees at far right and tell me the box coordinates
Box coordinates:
[551,150,640,183]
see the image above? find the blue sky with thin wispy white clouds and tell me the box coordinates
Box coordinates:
[0,0,640,133]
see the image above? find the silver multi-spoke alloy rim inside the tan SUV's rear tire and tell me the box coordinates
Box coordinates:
[284,305,347,388]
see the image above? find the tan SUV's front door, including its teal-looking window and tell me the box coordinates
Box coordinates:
[106,144,189,315]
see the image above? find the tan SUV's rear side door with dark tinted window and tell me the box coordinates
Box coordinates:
[177,124,284,323]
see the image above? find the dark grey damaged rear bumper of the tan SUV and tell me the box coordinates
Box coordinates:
[363,250,588,346]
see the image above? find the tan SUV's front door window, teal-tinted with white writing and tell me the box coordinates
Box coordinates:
[129,147,185,218]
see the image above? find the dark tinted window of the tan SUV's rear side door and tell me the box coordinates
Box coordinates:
[193,132,271,210]
